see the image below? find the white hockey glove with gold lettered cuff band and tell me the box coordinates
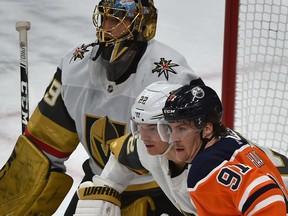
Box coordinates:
[74,175,124,216]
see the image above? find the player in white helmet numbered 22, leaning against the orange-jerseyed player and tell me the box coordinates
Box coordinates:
[75,82,288,216]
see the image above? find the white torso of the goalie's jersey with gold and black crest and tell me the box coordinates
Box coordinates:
[60,40,199,174]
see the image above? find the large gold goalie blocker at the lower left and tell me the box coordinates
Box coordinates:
[0,135,73,216]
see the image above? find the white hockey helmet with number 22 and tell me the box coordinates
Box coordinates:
[130,81,183,137]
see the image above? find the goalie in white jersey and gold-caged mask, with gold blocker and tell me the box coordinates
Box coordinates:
[0,0,203,215]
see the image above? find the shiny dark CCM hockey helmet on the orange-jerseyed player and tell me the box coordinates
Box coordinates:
[163,85,223,128]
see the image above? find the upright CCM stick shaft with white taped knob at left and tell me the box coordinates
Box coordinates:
[16,21,30,133]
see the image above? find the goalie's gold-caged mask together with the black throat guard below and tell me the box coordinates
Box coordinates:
[93,0,157,82]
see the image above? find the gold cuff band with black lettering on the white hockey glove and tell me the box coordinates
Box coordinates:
[78,186,121,207]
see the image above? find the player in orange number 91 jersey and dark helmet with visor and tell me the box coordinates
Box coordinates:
[158,85,287,216]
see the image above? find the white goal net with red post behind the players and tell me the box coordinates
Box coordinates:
[222,0,288,155]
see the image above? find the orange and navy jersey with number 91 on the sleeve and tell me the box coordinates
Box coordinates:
[187,131,287,216]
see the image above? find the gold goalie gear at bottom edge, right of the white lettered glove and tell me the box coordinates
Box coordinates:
[121,196,156,216]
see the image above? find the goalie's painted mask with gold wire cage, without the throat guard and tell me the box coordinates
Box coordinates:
[93,0,157,45]
